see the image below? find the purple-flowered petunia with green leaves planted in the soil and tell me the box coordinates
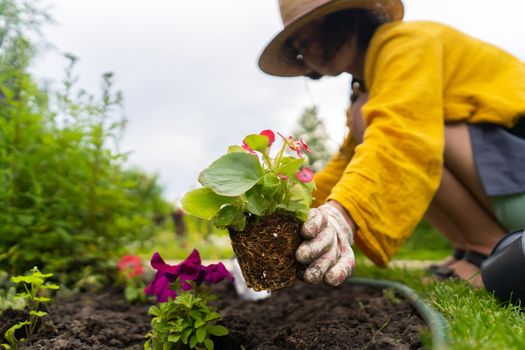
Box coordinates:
[144,250,233,350]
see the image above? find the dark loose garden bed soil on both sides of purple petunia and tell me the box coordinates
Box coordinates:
[0,282,426,350]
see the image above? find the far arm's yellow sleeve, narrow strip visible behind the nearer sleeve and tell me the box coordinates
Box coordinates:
[312,132,357,207]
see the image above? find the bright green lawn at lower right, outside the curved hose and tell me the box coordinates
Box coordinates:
[356,261,525,350]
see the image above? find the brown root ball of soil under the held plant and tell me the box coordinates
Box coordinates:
[230,215,304,291]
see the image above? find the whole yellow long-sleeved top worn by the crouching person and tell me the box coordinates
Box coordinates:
[314,22,525,266]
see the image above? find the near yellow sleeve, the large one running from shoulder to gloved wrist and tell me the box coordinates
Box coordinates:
[328,24,444,266]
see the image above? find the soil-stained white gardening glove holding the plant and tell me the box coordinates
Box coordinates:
[295,204,355,286]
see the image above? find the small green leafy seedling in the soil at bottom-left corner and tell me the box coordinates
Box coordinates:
[2,266,59,349]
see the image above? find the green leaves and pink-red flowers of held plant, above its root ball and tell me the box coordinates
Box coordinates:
[182,130,315,231]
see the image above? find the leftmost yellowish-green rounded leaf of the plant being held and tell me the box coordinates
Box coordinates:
[182,187,237,220]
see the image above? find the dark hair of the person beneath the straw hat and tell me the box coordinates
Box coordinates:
[288,9,387,79]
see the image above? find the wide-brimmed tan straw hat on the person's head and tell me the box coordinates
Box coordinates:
[259,0,404,77]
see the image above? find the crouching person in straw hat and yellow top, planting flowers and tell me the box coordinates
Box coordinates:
[259,0,525,286]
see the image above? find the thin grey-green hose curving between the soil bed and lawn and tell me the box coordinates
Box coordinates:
[347,277,449,350]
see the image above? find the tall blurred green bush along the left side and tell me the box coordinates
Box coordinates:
[0,0,171,282]
